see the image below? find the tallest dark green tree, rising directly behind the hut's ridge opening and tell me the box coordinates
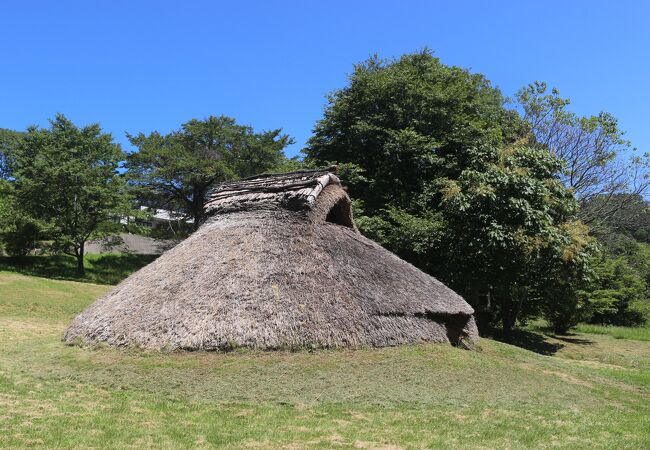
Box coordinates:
[304,49,523,215]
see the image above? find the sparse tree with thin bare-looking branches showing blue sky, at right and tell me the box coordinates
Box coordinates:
[517,82,650,225]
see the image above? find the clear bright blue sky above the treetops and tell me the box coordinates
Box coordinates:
[0,0,650,158]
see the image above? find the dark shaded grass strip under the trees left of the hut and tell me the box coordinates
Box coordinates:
[0,253,159,284]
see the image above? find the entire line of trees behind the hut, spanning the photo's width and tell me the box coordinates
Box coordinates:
[0,50,650,336]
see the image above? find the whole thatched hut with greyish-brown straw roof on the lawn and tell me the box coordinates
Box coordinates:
[64,170,478,350]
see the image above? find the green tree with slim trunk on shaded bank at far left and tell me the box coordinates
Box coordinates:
[12,114,127,275]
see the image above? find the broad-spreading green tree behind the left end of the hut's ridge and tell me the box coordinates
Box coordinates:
[127,116,293,229]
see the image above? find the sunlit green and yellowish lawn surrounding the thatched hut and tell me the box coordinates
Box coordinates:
[0,273,650,448]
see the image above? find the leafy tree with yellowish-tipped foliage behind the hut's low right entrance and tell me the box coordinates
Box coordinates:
[431,144,593,335]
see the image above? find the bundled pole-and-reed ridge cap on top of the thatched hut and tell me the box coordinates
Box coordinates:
[205,166,341,214]
